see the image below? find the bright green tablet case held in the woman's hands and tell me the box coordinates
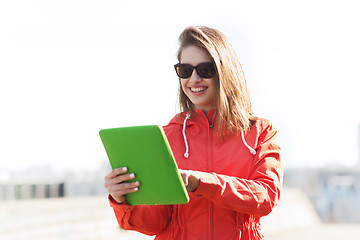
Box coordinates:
[99,125,189,205]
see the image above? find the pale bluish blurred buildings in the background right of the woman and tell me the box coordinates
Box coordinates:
[284,167,360,223]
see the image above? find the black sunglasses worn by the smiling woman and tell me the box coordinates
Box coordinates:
[174,62,216,78]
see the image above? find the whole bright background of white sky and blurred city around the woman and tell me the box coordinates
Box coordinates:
[0,0,360,240]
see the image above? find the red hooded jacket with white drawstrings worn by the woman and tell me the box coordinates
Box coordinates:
[110,111,283,240]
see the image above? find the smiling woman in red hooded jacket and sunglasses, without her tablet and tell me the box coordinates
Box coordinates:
[105,27,283,240]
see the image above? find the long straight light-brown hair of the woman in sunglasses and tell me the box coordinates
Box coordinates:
[177,26,256,139]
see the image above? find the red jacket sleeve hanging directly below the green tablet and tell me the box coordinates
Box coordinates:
[109,195,172,235]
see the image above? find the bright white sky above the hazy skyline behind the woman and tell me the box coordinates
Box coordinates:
[0,0,360,170]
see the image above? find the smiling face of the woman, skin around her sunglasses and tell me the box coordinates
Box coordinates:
[180,46,216,112]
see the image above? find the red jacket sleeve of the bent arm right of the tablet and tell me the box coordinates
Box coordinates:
[194,120,283,217]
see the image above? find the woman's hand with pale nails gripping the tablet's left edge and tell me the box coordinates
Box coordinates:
[104,167,140,203]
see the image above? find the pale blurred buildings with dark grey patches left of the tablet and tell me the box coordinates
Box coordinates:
[0,163,109,201]
